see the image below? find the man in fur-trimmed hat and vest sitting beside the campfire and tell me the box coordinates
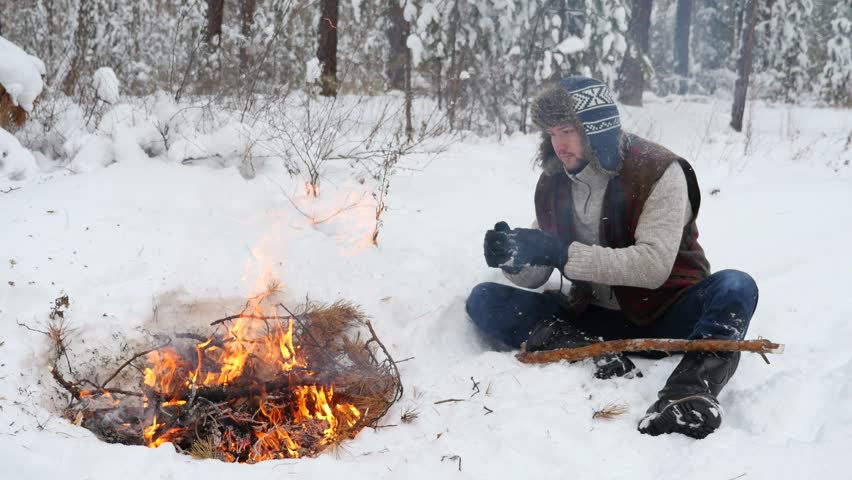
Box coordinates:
[467,77,758,438]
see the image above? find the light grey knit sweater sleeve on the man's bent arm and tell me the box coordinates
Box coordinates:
[564,162,692,289]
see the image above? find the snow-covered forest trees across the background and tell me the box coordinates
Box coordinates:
[0,0,852,133]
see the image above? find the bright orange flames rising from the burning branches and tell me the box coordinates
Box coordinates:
[143,282,362,462]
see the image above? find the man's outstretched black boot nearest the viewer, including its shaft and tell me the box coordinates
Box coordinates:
[639,352,740,438]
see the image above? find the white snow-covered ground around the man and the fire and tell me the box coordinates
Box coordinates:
[0,98,852,480]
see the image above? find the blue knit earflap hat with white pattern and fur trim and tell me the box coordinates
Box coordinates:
[532,76,621,172]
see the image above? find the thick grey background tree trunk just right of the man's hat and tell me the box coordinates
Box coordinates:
[618,0,653,107]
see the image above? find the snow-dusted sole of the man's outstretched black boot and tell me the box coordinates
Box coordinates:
[639,395,722,439]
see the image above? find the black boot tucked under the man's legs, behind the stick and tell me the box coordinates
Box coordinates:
[523,318,642,380]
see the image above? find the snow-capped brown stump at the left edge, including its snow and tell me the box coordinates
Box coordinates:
[0,37,46,130]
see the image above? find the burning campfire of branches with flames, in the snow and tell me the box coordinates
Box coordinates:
[51,286,402,463]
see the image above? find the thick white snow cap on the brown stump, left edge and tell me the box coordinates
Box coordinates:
[0,37,46,112]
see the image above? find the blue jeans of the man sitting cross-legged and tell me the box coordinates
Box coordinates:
[466,270,758,348]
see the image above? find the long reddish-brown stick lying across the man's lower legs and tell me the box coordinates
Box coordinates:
[515,338,784,363]
